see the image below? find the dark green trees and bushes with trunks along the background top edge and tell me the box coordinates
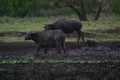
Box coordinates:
[0,0,120,21]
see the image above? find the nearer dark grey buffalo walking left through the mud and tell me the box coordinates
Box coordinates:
[25,30,65,53]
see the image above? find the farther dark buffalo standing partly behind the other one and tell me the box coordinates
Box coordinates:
[44,19,85,43]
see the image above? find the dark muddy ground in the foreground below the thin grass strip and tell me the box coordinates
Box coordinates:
[0,63,120,80]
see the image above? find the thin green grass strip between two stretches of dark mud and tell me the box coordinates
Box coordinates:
[0,59,120,64]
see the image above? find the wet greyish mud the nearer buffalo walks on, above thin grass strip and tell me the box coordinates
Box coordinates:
[0,42,120,60]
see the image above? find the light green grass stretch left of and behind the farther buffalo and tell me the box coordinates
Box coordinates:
[0,16,78,32]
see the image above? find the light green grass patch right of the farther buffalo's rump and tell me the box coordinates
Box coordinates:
[82,20,120,31]
